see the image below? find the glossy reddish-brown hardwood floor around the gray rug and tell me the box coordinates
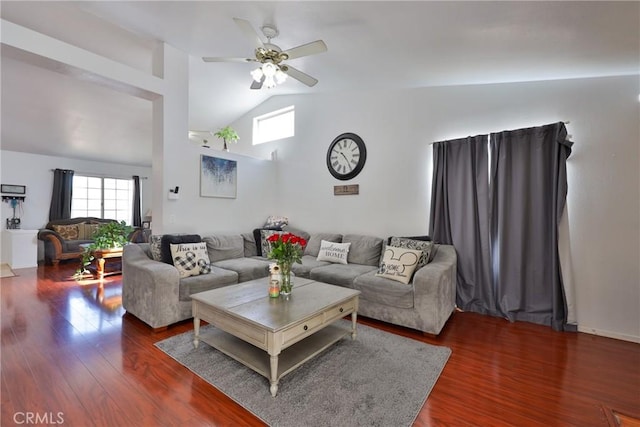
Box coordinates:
[0,264,640,426]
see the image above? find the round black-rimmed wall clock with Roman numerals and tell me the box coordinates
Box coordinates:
[327,133,367,181]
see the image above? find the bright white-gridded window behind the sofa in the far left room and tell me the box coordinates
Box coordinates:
[71,175,133,224]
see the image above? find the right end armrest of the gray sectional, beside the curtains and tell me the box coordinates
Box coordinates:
[413,245,457,335]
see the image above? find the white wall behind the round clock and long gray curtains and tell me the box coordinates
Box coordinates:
[232,76,640,342]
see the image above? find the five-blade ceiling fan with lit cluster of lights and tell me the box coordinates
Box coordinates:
[202,18,327,89]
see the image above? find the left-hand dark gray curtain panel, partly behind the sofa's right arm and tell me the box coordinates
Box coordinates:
[429,135,503,317]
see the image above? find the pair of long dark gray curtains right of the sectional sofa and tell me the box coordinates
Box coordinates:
[429,123,575,330]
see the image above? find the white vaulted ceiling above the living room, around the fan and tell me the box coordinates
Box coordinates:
[0,1,640,165]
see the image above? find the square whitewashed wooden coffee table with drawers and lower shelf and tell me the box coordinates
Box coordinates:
[191,277,360,397]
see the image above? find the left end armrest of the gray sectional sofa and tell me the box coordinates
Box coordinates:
[122,244,180,328]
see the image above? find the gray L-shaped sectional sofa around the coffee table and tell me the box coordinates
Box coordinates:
[122,232,457,335]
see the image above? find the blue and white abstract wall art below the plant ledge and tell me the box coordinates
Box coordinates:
[200,154,238,199]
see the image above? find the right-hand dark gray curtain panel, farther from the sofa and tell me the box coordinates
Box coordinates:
[490,123,573,330]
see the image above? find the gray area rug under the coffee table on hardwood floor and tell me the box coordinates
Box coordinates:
[155,320,451,427]
